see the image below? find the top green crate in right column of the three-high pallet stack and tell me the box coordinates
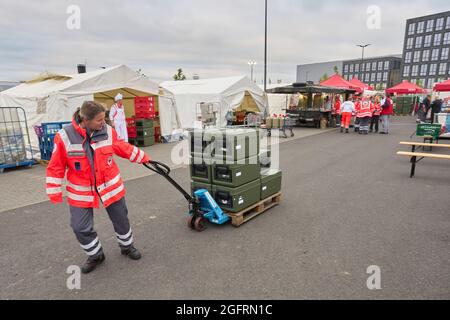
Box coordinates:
[213,129,259,161]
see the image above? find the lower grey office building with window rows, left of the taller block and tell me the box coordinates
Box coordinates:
[342,54,402,90]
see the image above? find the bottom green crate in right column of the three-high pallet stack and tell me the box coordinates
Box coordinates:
[212,179,261,213]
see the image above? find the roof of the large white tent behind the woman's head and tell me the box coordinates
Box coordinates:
[0,65,162,146]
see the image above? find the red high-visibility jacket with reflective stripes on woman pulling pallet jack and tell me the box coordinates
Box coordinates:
[46,120,150,208]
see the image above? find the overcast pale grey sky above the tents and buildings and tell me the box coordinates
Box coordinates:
[0,0,450,83]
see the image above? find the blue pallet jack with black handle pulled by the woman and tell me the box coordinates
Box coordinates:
[144,161,231,232]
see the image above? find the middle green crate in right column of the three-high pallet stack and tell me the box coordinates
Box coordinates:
[212,156,261,188]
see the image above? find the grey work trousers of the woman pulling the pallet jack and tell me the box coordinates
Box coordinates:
[70,198,133,259]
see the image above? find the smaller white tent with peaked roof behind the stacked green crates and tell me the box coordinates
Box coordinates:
[160,76,267,129]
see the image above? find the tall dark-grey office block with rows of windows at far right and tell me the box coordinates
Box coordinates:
[401,11,450,89]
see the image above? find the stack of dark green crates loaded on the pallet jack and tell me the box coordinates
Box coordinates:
[190,129,281,213]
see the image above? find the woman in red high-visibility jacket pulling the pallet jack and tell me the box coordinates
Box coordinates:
[46,101,150,273]
